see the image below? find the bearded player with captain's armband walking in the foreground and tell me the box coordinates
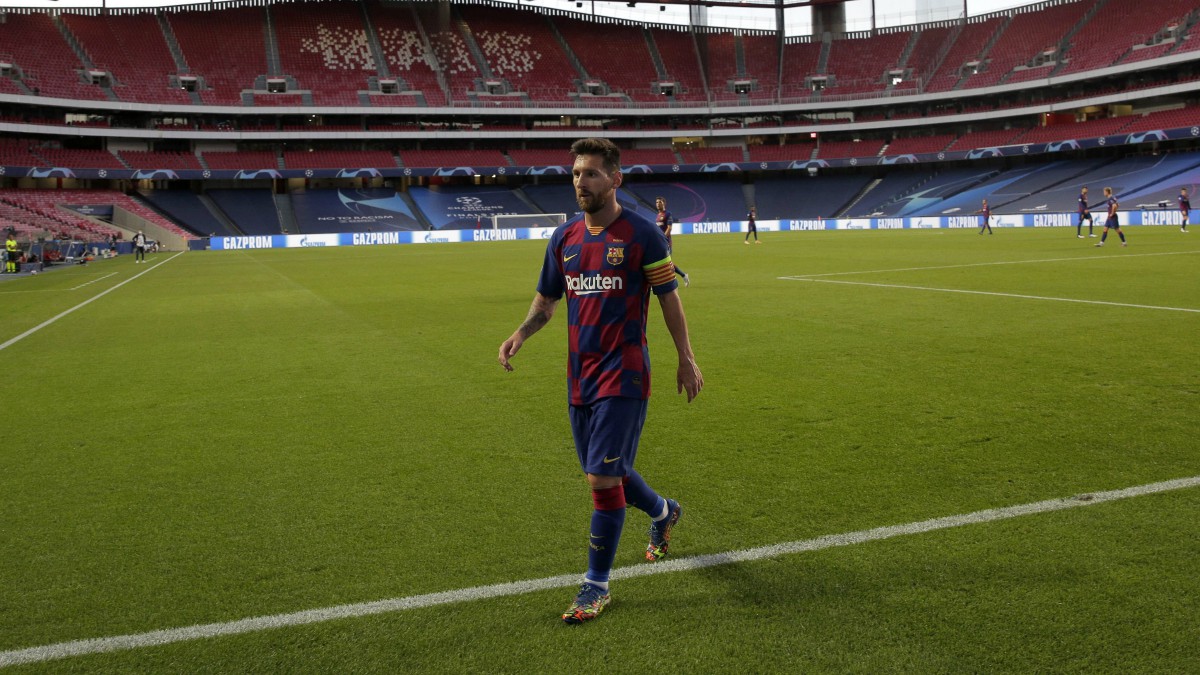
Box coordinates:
[499,138,704,623]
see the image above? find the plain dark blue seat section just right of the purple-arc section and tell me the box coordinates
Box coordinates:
[755,174,871,220]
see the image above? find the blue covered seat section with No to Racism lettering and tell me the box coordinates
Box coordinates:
[289,187,425,234]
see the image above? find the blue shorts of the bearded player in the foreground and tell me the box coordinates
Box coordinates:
[570,396,648,477]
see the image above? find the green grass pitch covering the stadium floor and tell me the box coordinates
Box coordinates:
[0,227,1200,673]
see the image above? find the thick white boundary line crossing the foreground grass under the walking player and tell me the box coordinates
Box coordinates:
[0,476,1200,668]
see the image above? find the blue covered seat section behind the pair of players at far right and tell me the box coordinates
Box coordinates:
[989,155,1164,214]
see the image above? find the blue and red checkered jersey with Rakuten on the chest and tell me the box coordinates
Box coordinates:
[538,210,678,406]
